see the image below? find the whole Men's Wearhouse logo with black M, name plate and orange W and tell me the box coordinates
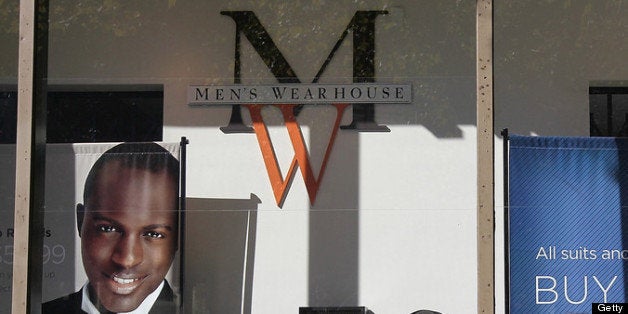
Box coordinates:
[188,11,412,207]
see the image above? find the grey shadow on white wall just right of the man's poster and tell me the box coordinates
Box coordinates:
[183,194,260,314]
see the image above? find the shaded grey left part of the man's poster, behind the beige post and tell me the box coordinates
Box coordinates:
[0,144,77,304]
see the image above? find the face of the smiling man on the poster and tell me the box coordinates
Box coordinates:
[79,162,178,312]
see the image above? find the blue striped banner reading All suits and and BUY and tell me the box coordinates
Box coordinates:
[509,136,628,314]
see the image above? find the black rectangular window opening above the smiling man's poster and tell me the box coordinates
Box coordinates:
[0,90,163,144]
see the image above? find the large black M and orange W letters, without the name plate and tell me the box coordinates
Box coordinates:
[221,11,388,207]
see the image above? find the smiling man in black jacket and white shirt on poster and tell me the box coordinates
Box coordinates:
[42,143,179,314]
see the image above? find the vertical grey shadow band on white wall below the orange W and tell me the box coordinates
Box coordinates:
[304,118,360,307]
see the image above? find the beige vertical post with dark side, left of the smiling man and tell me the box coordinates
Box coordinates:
[11,0,48,313]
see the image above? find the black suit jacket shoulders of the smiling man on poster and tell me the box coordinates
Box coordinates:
[41,281,177,314]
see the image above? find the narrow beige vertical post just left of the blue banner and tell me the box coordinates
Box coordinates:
[476,0,495,313]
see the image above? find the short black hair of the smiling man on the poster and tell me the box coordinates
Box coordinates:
[83,142,179,208]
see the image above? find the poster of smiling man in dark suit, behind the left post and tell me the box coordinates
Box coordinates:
[0,142,181,313]
